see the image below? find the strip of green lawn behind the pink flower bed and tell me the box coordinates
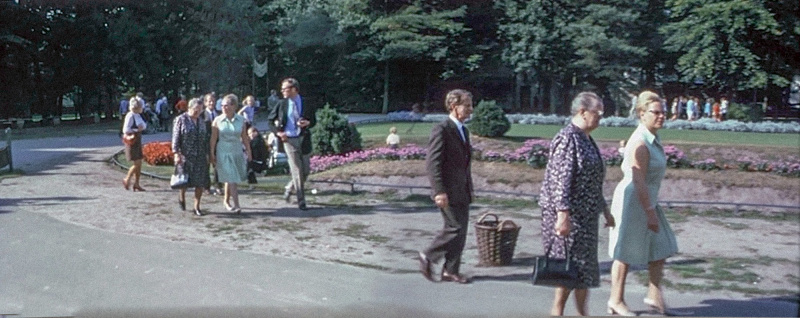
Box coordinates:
[357,122,800,149]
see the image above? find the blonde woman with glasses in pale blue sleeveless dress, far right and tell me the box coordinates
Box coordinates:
[608,91,678,316]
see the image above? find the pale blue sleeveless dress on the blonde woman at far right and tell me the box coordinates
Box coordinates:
[608,125,678,265]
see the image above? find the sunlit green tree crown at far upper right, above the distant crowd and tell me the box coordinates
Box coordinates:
[661,0,784,92]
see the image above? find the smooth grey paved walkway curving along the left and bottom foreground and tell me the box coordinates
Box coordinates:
[0,118,798,317]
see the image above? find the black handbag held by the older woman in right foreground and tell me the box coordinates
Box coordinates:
[531,238,580,289]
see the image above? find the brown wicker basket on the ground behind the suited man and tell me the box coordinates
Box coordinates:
[475,212,521,266]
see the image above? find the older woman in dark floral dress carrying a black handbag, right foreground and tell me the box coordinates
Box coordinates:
[539,92,614,316]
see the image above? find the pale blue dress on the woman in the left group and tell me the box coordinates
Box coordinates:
[214,115,247,183]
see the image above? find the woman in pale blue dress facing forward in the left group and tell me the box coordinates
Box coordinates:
[211,94,252,213]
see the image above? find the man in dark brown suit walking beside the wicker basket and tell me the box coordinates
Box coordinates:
[419,89,473,284]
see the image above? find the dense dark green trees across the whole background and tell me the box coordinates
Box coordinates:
[0,0,800,118]
